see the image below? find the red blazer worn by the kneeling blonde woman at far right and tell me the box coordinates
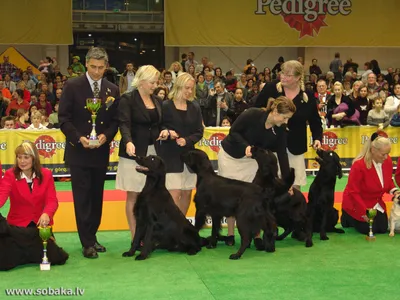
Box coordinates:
[342,156,395,222]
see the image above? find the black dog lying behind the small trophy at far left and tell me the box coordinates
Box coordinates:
[0,214,68,271]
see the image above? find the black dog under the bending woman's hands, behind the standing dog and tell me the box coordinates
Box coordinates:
[251,147,312,247]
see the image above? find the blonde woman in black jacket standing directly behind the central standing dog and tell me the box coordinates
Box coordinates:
[159,73,204,215]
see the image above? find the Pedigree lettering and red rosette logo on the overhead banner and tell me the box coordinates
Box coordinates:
[255,0,352,38]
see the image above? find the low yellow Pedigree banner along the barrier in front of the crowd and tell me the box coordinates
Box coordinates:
[0,126,400,176]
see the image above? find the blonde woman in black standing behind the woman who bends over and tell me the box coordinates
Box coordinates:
[255,60,322,189]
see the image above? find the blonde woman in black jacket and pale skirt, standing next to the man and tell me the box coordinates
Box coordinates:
[115,65,161,256]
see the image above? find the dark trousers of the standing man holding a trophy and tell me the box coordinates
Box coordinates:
[70,166,107,247]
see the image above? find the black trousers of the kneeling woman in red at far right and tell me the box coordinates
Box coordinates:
[340,210,388,234]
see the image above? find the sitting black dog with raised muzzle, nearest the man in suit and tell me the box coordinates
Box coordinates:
[123,155,202,260]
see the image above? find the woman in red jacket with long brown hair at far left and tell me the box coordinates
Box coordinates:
[0,142,58,227]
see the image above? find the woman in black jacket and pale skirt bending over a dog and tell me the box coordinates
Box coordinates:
[218,96,296,247]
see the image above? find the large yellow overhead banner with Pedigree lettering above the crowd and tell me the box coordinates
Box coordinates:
[165,0,400,47]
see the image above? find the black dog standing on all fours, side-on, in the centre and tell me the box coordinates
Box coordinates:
[182,149,276,259]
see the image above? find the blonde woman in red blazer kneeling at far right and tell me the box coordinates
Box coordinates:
[341,133,400,234]
